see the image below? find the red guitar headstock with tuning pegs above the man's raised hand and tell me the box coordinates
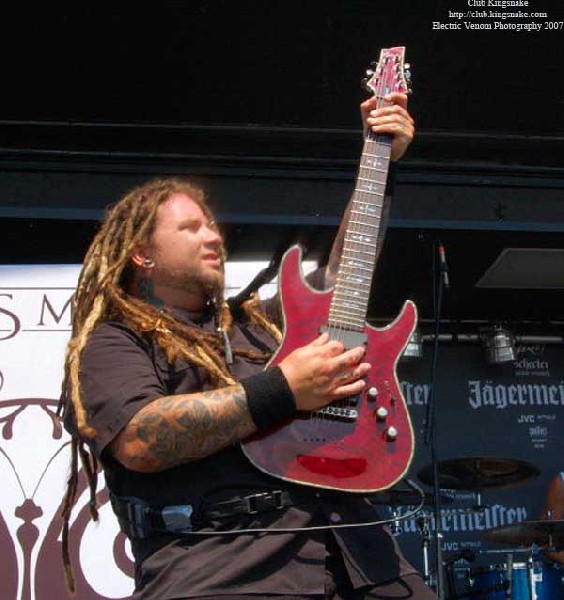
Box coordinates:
[362,46,411,98]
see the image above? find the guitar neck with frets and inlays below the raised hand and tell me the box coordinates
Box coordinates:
[328,131,391,331]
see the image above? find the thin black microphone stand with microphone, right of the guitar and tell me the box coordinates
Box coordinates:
[425,241,449,600]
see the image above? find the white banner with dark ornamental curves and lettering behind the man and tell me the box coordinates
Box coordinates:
[0,261,315,600]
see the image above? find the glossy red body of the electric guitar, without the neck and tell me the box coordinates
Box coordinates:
[242,246,417,492]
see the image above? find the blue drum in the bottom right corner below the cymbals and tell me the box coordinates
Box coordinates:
[468,561,564,600]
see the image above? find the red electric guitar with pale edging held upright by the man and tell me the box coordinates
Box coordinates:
[242,47,417,492]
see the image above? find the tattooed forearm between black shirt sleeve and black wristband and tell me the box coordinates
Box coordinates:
[118,385,255,471]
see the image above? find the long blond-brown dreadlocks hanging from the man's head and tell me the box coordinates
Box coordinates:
[58,177,282,591]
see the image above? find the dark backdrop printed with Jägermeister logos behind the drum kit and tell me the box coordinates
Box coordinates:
[392,344,564,592]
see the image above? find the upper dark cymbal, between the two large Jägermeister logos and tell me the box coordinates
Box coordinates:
[417,456,540,490]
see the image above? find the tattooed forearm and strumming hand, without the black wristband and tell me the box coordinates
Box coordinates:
[110,333,370,472]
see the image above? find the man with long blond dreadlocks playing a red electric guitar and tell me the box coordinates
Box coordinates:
[61,93,435,600]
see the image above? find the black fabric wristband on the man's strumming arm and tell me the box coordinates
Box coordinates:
[240,367,297,431]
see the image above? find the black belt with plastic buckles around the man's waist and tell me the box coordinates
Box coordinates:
[110,490,302,539]
